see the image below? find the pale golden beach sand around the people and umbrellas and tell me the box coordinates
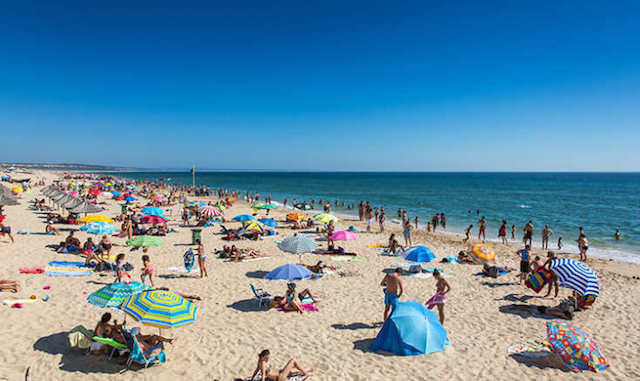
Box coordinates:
[0,172,640,381]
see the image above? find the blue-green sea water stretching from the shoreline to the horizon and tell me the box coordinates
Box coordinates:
[111,171,640,263]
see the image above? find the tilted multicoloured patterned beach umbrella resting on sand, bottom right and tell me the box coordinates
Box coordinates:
[547,320,609,372]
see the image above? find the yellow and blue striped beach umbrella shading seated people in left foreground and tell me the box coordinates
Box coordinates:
[122,290,198,328]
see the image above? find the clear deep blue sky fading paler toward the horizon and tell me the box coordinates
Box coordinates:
[0,0,640,171]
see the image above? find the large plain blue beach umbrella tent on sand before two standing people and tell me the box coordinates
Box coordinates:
[370,301,449,356]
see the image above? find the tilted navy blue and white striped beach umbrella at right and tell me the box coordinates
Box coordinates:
[550,258,600,296]
